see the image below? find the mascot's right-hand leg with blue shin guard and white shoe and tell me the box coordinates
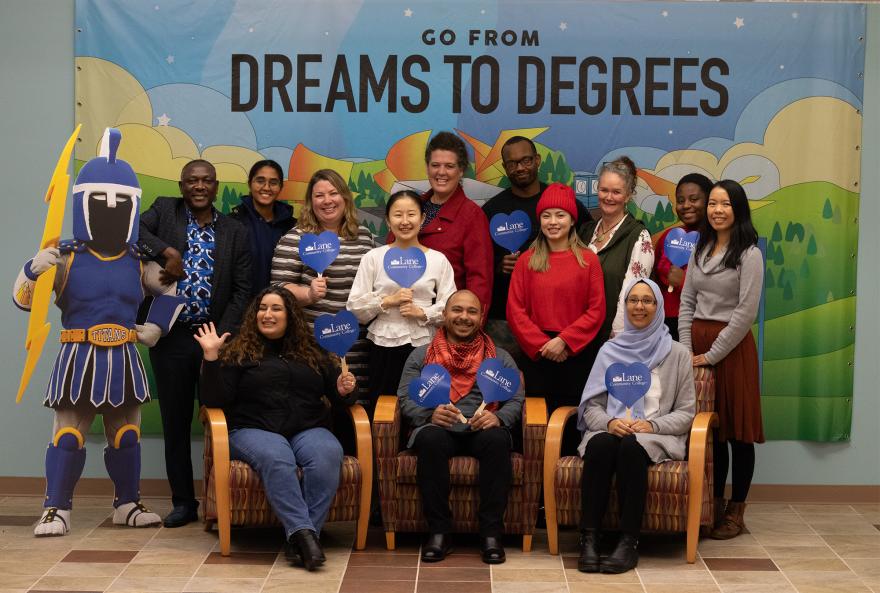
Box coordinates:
[104,424,161,527]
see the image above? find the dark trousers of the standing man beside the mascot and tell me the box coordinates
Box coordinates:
[150,324,202,509]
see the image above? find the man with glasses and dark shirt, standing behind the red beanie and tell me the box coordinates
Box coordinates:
[483,136,592,363]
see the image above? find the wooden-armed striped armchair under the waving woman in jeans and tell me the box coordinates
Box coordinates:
[199,404,373,556]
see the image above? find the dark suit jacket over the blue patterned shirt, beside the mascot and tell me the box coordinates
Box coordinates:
[138,197,251,335]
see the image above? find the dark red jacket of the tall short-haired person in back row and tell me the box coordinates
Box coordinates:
[388,185,493,322]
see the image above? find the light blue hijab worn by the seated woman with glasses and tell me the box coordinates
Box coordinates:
[578,278,672,432]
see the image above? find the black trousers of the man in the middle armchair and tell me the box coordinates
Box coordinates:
[413,425,513,537]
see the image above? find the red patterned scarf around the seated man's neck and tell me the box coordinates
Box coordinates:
[425,327,498,410]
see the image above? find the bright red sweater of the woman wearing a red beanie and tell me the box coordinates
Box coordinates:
[507,249,605,360]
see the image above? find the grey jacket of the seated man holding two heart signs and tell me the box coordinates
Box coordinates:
[397,344,525,447]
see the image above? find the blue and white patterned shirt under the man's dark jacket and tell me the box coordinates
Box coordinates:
[177,208,217,323]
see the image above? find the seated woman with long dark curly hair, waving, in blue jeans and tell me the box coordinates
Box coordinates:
[195,287,355,570]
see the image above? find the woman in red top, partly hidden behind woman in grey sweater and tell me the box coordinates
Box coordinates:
[654,173,712,342]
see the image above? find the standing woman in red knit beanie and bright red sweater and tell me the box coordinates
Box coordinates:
[507,183,605,411]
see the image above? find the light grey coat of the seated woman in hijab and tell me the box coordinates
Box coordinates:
[578,342,696,463]
